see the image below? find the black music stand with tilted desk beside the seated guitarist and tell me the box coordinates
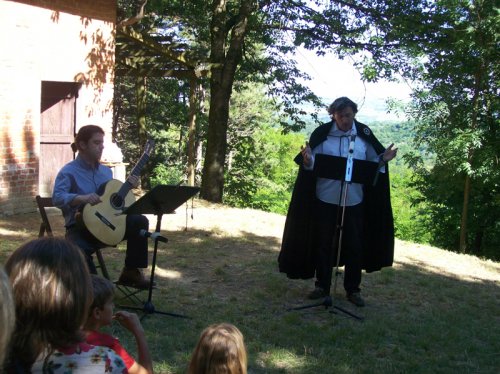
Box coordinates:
[123,185,200,319]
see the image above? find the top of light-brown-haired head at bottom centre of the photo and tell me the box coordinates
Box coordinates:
[188,323,247,374]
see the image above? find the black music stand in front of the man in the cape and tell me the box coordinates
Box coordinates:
[290,154,381,321]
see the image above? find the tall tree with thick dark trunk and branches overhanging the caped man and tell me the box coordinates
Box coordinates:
[119,0,470,202]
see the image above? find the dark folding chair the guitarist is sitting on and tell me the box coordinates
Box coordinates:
[36,195,145,304]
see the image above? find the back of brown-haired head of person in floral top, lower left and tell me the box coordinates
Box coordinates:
[5,237,92,371]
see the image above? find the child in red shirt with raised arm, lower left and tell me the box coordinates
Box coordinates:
[84,275,153,374]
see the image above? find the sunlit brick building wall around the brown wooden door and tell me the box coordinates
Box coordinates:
[0,0,116,215]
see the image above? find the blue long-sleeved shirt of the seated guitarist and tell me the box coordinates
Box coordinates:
[52,156,113,227]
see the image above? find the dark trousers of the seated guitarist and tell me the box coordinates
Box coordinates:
[66,214,149,274]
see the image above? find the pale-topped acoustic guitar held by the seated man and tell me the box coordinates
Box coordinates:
[80,140,154,246]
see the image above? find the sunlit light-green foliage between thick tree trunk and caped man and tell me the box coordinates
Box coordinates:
[224,83,304,214]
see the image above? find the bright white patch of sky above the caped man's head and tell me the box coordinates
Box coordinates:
[296,48,411,121]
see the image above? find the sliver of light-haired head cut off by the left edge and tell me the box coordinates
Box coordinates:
[0,268,16,372]
